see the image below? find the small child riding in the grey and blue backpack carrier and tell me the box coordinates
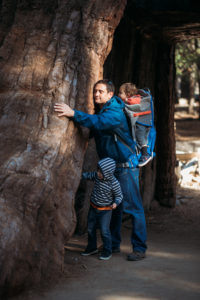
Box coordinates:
[118,83,153,167]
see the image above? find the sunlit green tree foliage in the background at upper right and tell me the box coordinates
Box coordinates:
[175,38,200,118]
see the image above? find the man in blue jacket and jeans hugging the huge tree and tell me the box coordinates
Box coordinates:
[54,79,147,261]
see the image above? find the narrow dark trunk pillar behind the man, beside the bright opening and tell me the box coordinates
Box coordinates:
[155,41,176,207]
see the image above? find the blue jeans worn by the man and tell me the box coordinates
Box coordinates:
[110,168,147,252]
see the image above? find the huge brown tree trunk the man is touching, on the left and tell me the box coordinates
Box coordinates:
[0,0,126,291]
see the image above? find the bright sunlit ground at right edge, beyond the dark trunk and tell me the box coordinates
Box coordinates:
[175,99,200,190]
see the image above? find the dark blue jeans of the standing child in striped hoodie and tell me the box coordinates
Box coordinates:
[87,206,112,254]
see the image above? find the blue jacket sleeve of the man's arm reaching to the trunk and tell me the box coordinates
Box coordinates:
[73,109,121,130]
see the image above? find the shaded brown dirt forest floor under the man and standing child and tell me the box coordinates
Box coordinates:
[14,110,200,300]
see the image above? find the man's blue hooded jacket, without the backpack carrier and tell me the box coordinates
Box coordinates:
[73,96,138,167]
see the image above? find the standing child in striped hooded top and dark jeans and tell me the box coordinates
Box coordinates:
[81,157,123,260]
